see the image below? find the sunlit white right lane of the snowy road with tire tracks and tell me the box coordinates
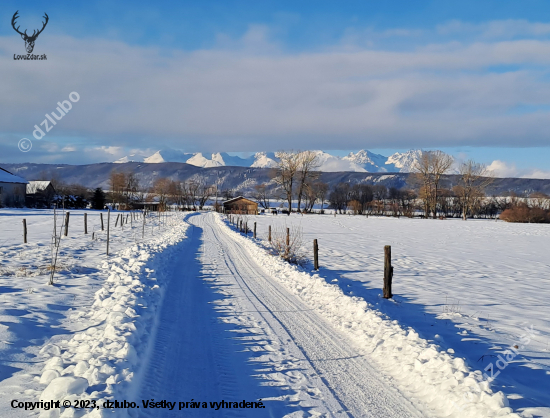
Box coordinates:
[201,215,422,418]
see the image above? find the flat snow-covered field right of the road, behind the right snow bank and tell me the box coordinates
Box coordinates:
[239,214,550,416]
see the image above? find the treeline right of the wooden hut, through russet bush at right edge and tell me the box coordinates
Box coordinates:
[254,151,550,222]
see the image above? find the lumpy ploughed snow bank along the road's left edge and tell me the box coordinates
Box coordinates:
[40,214,188,418]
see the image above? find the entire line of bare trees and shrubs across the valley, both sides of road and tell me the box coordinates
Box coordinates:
[29,158,550,222]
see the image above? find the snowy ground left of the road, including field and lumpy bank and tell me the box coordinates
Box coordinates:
[0,209,186,417]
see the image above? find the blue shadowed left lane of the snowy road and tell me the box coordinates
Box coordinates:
[135,220,251,417]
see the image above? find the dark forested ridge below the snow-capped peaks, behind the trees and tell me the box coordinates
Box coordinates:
[0,162,550,196]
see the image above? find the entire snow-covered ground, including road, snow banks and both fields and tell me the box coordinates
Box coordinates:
[0,210,550,418]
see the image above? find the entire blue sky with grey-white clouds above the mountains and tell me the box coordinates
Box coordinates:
[0,0,550,176]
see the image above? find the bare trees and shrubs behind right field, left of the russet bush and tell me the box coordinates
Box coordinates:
[270,151,498,219]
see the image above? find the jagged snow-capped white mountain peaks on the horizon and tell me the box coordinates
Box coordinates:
[115,148,422,173]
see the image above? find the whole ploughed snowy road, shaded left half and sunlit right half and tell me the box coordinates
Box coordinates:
[134,214,429,418]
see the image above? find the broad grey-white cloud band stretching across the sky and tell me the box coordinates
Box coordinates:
[0,26,550,158]
